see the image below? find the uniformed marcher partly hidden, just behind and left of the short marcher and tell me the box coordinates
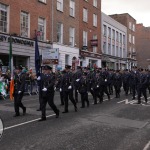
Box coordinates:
[74,66,82,103]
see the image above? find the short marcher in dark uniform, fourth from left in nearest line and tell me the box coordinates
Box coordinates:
[79,72,89,108]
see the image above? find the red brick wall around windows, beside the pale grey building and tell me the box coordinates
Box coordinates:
[79,0,101,53]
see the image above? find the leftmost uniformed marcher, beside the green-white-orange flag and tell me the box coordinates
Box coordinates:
[14,66,26,117]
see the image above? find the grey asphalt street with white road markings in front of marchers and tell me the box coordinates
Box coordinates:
[0,92,150,150]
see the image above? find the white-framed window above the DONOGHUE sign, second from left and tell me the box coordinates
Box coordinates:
[20,12,29,37]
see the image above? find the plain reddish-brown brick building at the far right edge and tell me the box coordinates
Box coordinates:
[136,24,150,69]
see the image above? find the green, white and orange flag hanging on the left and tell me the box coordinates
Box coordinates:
[9,36,14,100]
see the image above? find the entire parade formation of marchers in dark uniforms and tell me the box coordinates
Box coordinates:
[0,65,150,121]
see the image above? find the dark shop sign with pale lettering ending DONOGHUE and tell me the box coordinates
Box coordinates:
[0,34,34,47]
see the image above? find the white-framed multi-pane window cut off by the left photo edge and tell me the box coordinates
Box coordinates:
[0,3,8,33]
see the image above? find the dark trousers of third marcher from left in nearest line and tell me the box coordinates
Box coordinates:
[64,90,77,111]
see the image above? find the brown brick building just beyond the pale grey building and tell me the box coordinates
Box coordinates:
[110,13,137,68]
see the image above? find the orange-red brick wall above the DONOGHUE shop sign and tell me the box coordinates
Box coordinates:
[0,0,51,39]
